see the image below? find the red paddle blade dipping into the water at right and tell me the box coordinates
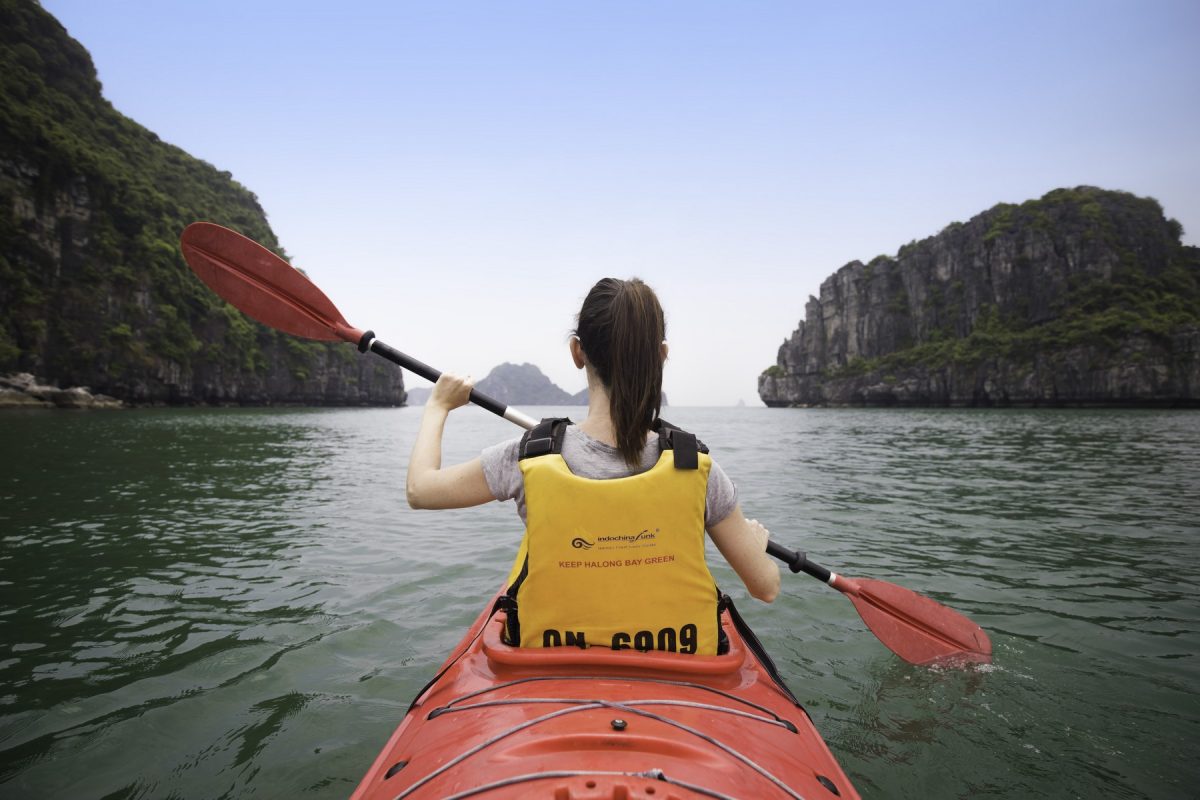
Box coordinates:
[834,576,991,666]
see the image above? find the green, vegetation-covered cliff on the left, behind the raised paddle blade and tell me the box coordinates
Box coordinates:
[0,0,404,404]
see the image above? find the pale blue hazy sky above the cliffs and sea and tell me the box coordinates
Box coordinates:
[42,0,1200,405]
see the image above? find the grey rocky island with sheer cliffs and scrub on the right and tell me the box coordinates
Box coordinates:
[758,186,1200,407]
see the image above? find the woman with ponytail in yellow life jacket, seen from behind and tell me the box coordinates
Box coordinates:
[407,278,779,654]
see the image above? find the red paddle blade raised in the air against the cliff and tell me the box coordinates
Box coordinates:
[179,222,362,344]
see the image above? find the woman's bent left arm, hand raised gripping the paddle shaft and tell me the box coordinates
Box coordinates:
[404,372,496,509]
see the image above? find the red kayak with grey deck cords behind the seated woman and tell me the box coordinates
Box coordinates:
[352,594,859,800]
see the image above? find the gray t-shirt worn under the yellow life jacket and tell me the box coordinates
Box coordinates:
[480,425,738,528]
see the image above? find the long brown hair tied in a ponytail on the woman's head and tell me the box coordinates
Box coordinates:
[575,278,667,467]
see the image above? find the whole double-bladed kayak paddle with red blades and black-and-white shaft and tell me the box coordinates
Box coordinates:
[180,222,991,664]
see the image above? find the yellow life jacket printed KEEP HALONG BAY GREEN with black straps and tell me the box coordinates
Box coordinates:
[506,420,721,655]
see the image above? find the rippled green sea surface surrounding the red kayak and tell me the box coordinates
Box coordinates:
[0,408,1200,800]
